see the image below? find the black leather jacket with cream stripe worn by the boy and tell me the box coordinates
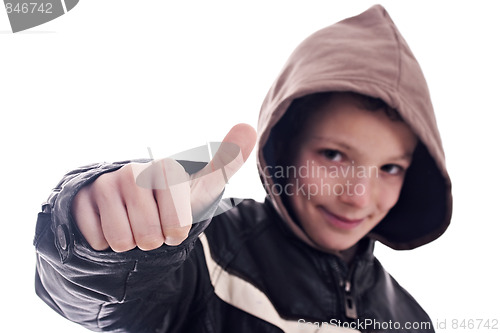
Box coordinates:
[34,163,433,333]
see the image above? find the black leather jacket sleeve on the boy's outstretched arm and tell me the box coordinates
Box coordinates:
[34,162,220,333]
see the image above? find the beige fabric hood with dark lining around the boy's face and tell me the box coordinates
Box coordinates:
[258,5,452,249]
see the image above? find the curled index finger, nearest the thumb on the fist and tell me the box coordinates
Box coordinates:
[154,159,192,245]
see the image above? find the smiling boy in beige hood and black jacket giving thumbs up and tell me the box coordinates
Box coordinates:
[35,6,451,333]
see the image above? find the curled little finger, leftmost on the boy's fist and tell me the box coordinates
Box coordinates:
[71,187,109,251]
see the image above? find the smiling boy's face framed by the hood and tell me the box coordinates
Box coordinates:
[288,96,417,251]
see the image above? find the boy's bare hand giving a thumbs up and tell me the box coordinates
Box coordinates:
[72,124,257,252]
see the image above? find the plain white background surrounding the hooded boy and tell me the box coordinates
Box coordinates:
[0,0,500,333]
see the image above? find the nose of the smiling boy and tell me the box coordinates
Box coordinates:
[338,171,376,208]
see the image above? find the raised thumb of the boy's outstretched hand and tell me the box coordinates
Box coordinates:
[191,124,257,201]
